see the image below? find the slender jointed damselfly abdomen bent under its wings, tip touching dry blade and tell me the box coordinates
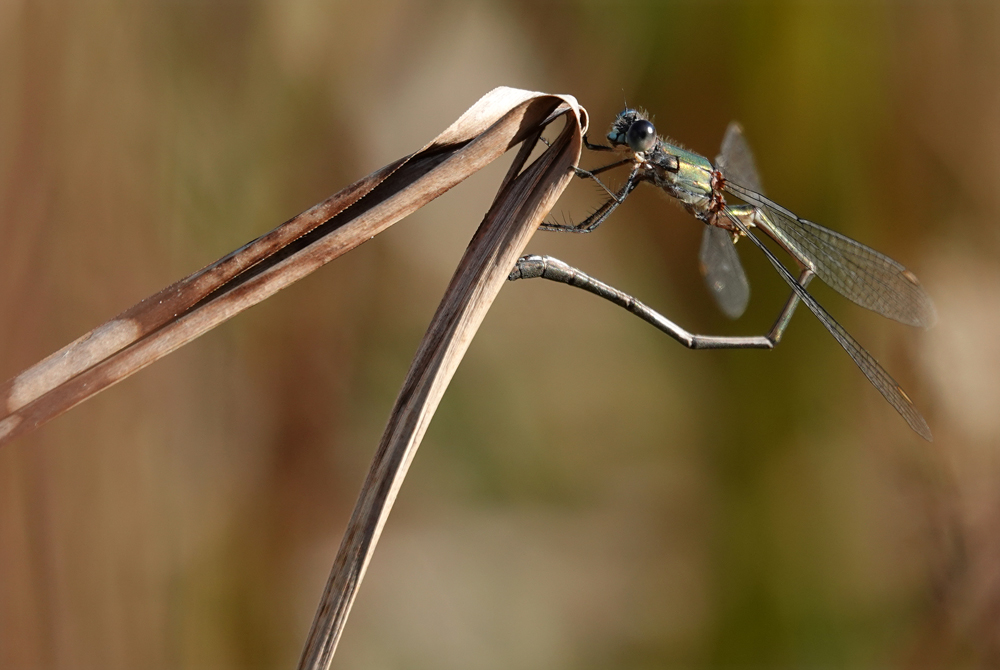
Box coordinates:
[507,255,813,349]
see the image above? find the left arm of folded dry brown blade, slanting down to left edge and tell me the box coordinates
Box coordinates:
[0,88,575,445]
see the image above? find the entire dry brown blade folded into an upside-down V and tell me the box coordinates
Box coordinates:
[0,88,587,668]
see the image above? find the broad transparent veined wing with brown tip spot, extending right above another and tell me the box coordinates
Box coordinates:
[725,182,937,327]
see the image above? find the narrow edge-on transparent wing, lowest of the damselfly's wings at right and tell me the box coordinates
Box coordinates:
[730,210,933,442]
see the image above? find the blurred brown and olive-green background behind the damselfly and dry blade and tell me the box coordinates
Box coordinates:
[0,0,1000,669]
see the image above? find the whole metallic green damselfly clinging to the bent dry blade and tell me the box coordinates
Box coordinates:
[510,109,936,440]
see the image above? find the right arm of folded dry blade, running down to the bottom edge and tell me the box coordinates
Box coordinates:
[299,100,586,670]
